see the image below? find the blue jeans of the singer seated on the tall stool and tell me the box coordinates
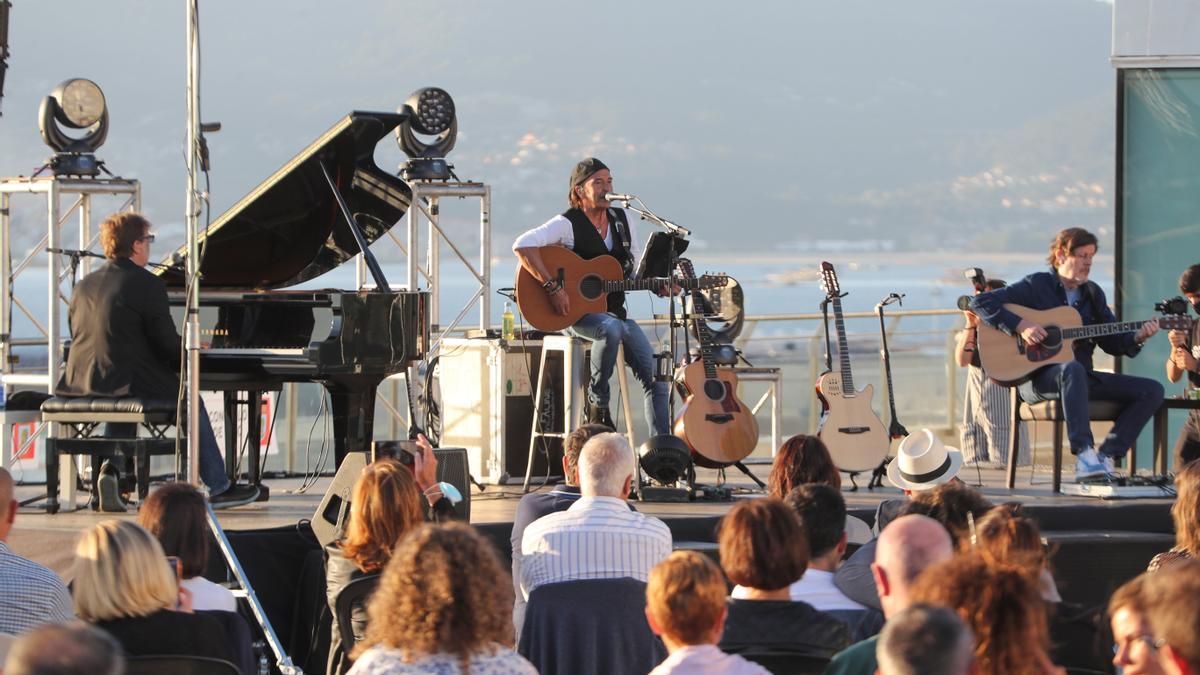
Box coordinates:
[568,312,671,435]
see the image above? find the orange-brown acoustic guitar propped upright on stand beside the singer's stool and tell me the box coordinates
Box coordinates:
[674,258,758,468]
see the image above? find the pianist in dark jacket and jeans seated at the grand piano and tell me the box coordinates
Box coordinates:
[55,211,258,510]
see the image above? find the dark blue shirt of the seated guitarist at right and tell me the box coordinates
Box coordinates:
[971,271,1141,370]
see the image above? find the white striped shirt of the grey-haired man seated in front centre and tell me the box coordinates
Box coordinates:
[521,497,671,598]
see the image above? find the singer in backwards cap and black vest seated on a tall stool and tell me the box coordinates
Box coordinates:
[512,157,671,435]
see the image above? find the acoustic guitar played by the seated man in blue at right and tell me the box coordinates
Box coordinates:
[976,305,1192,386]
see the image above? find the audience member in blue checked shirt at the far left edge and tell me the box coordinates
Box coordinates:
[0,468,74,635]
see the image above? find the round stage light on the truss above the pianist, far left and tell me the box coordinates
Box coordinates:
[37,78,108,175]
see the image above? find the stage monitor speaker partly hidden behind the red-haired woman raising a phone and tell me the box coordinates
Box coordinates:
[312,448,470,546]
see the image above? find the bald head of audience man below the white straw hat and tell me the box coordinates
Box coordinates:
[871,515,954,616]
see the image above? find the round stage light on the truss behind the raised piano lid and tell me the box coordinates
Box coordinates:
[396,86,458,180]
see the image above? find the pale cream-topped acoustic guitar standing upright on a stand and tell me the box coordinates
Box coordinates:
[817,262,890,473]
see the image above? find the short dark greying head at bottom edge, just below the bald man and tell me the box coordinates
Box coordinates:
[877,604,977,675]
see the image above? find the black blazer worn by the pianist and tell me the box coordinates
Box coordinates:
[55,258,180,399]
